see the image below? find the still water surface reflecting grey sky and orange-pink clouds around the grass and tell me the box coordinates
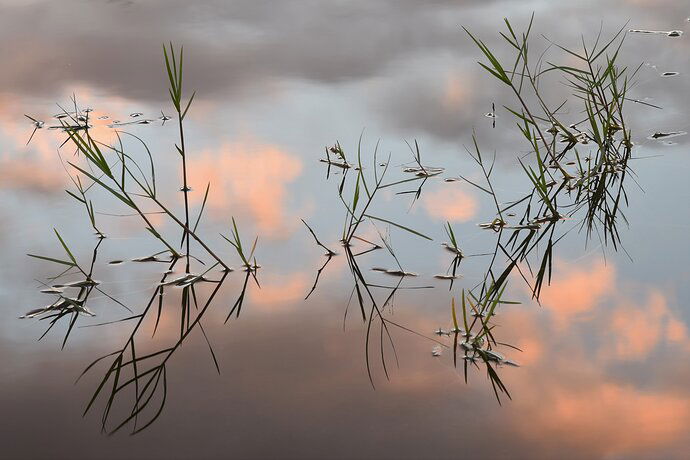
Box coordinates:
[0,0,690,459]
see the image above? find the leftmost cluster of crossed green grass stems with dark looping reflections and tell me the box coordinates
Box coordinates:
[24,43,259,433]
